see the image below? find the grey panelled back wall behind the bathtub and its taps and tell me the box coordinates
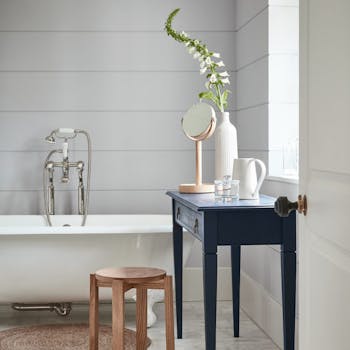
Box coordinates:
[0,0,235,214]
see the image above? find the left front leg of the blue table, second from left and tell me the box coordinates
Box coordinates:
[203,253,217,350]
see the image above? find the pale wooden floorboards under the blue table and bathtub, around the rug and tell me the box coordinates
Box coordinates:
[0,302,279,350]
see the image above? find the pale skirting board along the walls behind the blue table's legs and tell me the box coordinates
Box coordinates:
[183,267,298,350]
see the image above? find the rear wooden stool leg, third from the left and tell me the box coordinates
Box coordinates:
[136,287,147,350]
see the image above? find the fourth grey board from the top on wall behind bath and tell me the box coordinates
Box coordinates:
[0,110,220,151]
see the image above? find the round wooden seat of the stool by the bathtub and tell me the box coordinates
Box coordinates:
[95,267,166,283]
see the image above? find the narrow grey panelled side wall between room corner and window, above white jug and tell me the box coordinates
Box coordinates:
[236,0,269,164]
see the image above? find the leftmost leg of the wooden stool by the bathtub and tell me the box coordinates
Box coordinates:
[89,274,99,350]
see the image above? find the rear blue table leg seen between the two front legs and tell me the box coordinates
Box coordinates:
[231,245,241,338]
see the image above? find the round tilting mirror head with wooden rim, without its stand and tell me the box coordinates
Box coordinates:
[182,103,216,141]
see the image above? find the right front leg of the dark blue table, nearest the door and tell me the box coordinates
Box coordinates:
[281,251,296,350]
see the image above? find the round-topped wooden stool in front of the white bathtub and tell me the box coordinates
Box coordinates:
[89,267,175,350]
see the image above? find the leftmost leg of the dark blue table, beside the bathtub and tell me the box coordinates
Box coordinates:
[173,221,183,339]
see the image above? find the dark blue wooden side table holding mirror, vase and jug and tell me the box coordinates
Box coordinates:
[167,191,296,350]
